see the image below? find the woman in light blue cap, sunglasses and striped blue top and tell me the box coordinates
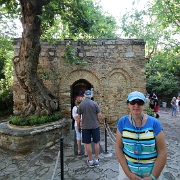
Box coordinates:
[115,91,167,180]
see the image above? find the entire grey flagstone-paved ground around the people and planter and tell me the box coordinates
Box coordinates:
[0,108,180,180]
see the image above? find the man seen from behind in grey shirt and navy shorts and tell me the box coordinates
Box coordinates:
[77,90,102,167]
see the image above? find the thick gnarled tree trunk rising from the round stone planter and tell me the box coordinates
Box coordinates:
[13,0,58,116]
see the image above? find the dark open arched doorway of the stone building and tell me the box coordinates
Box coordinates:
[71,79,93,129]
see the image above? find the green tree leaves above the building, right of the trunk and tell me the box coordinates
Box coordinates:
[40,0,118,40]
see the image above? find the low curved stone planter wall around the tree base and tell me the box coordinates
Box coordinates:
[0,118,72,153]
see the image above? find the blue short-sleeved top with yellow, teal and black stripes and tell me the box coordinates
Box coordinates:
[117,116,162,177]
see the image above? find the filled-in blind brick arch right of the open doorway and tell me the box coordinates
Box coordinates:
[106,68,133,122]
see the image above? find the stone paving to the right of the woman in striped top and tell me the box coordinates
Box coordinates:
[159,108,180,180]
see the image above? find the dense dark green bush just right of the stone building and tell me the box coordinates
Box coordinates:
[146,48,180,97]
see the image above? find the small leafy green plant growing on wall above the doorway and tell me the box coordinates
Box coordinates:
[64,43,88,66]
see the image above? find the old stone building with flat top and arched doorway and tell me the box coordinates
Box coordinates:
[13,39,146,127]
